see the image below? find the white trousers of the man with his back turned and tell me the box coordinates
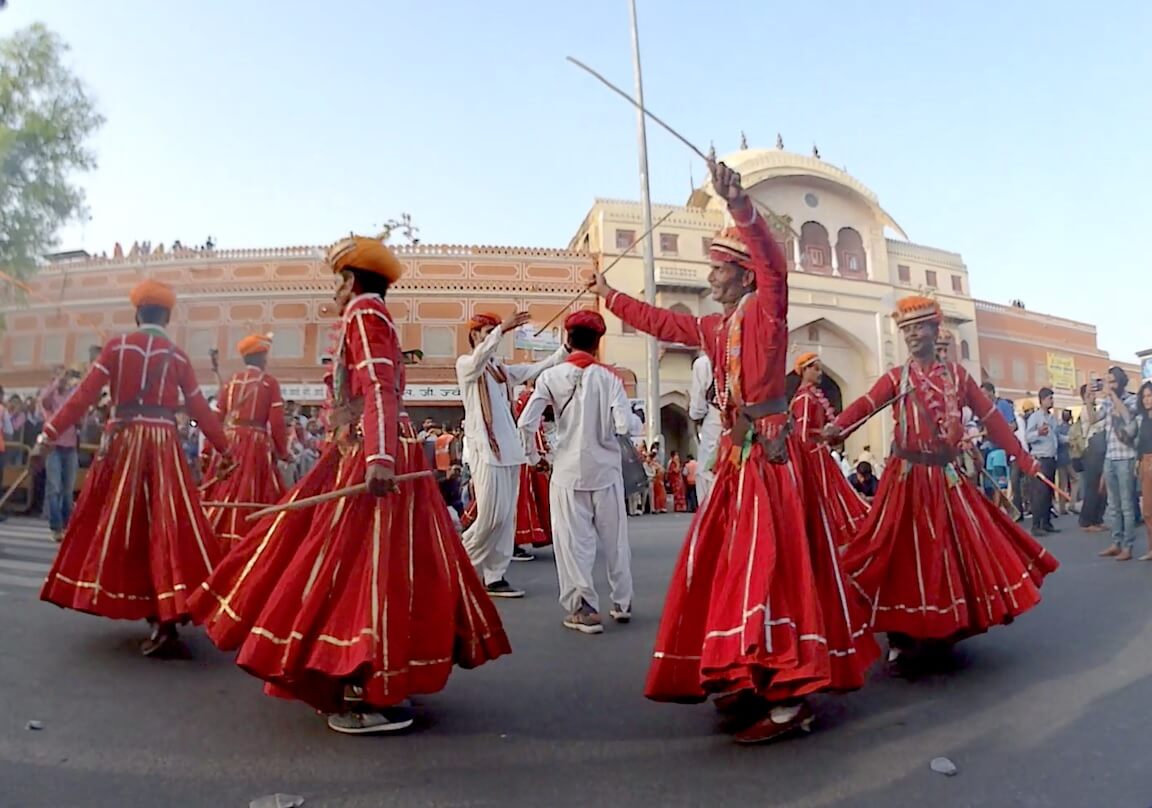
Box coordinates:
[548,482,632,613]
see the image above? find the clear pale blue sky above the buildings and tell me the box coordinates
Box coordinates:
[0,0,1152,360]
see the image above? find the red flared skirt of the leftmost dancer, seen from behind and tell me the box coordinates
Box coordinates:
[40,422,220,621]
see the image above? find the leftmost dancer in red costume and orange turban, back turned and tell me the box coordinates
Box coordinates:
[40,280,232,656]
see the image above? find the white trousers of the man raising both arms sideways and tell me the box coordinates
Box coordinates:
[463,460,520,586]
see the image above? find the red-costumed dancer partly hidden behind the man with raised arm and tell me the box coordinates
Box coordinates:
[791,353,867,548]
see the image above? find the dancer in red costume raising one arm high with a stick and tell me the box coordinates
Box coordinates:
[593,164,879,743]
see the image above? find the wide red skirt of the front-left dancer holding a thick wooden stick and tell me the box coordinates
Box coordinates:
[191,424,511,712]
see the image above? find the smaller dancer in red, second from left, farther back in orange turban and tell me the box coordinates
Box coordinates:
[204,334,288,554]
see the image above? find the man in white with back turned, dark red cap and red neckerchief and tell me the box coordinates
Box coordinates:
[520,311,632,634]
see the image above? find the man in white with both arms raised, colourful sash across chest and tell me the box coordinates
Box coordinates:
[456,312,568,597]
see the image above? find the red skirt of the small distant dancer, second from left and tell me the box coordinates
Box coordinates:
[204,426,285,554]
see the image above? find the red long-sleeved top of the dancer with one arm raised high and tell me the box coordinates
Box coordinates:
[605,196,788,417]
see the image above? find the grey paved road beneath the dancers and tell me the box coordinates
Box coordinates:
[0,516,1152,808]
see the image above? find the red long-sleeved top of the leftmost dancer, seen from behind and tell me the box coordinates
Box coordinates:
[44,326,228,454]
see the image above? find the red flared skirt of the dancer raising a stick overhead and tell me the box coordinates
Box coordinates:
[645,436,879,703]
